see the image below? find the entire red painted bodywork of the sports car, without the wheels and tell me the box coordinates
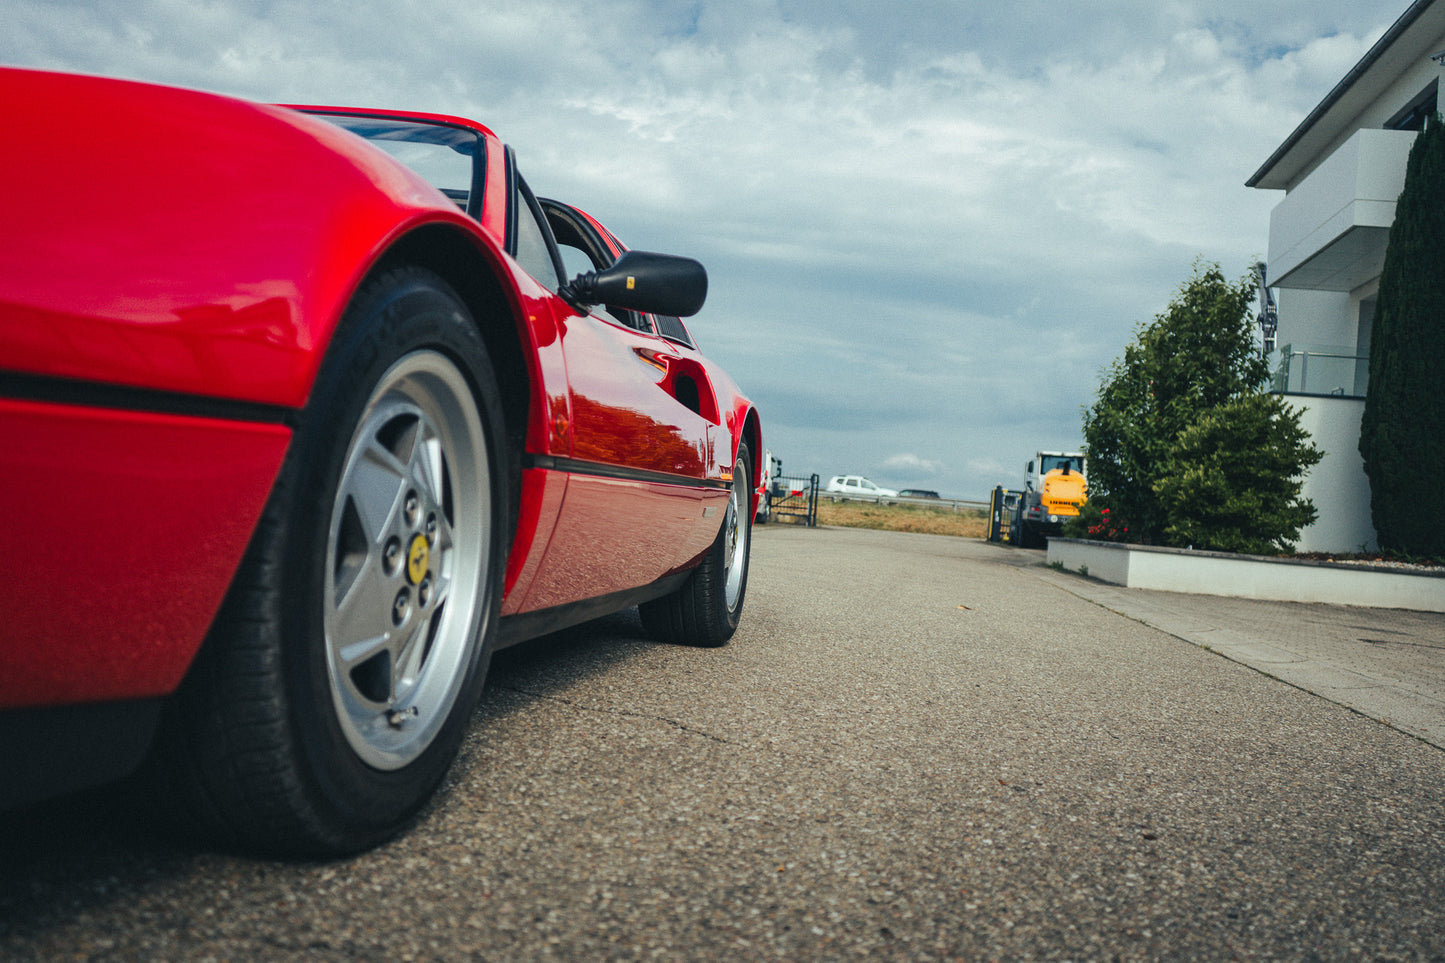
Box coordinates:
[0,68,760,731]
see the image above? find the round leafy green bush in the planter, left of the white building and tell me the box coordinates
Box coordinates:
[1086,265,1321,552]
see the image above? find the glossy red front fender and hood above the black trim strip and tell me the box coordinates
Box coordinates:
[0,71,482,408]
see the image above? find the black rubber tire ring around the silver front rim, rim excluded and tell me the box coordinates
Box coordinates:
[280,270,509,844]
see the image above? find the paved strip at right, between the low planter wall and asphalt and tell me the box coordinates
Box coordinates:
[1032,565,1445,749]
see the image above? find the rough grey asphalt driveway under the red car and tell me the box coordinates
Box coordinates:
[0,526,1445,963]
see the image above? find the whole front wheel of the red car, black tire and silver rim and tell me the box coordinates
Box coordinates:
[158,269,510,856]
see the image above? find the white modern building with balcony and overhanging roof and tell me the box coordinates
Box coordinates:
[1246,0,1445,552]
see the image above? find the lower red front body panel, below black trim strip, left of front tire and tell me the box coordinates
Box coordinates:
[0,399,290,709]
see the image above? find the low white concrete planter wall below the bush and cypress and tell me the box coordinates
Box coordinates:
[1048,538,1445,612]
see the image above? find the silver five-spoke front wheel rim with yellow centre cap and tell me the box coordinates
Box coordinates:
[324,351,491,771]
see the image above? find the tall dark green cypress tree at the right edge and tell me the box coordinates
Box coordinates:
[1360,114,1445,557]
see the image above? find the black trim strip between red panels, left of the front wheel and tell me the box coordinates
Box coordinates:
[0,372,301,428]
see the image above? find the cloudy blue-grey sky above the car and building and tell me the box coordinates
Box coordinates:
[0,0,1407,497]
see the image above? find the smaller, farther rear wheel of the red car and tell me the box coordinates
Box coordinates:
[637,442,753,646]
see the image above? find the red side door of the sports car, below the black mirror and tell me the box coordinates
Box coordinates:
[519,184,733,610]
